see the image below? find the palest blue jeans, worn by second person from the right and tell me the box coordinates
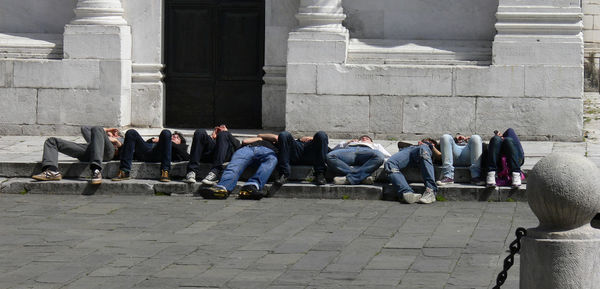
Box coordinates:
[440,134,483,179]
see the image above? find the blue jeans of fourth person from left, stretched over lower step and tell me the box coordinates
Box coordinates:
[217,146,277,192]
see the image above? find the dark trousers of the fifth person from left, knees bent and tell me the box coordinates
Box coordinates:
[277,131,329,176]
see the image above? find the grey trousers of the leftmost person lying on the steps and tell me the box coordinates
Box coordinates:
[42,126,115,168]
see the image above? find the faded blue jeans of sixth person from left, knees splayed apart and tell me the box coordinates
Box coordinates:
[327,146,385,185]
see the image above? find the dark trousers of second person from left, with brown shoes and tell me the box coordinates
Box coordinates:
[120,129,172,171]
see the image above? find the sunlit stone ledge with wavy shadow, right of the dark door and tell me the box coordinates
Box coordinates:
[347,39,492,65]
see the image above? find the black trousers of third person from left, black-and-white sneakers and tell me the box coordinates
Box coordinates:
[187,129,237,174]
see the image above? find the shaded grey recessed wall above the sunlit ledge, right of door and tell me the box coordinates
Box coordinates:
[342,0,498,40]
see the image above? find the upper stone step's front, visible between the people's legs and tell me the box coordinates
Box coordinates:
[0,161,530,183]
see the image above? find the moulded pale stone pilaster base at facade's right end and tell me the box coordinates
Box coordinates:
[493,0,583,66]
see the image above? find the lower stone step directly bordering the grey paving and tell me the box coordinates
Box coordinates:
[0,178,527,201]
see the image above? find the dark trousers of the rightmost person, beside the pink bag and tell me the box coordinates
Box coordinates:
[488,136,525,172]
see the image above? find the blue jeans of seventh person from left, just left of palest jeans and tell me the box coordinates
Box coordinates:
[384,144,437,197]
